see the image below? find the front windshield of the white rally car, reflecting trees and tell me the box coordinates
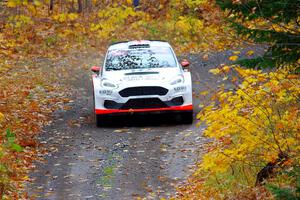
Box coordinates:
[105,47,176,71]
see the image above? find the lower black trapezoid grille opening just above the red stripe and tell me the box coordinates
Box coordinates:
[121,98,168,110]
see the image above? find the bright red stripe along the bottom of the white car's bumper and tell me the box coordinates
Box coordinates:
[95,105,193,115]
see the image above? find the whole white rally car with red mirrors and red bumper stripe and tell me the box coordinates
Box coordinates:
[91,40,193,126]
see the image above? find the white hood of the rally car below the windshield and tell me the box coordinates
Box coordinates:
[103,67,181,83]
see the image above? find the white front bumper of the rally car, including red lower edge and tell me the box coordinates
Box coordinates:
[94,78,193,115]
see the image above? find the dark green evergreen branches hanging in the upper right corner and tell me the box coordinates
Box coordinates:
[216,0,300,68]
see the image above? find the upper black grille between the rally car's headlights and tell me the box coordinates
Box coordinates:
[119,86,168,97]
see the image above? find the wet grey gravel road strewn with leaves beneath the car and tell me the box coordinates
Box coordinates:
[27,46,262,200]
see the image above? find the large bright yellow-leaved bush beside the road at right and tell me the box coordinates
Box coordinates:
[197,66,300,195]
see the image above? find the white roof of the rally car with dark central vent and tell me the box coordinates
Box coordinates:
[108,40,171,50]
